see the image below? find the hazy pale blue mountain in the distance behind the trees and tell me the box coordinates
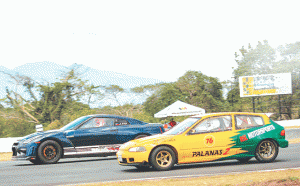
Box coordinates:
[0,62,163,106]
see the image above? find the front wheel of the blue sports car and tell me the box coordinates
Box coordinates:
[38,140,62,164]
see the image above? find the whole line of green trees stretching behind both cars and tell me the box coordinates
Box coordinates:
[0,41,300,137]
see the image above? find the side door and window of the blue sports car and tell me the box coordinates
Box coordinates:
[67,117,117,147]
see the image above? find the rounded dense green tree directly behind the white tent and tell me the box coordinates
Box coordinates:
[144,71,224,116]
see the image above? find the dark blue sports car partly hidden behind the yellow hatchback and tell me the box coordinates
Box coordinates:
[12,115,164,164]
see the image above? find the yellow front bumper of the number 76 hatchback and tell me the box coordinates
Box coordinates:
[117,150,150,166]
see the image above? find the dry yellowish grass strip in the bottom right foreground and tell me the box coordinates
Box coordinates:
[81,169,300,186]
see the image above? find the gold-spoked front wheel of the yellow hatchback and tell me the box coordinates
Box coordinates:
[149,146,176,171]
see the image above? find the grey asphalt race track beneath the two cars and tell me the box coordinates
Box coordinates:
[0,129,300,185]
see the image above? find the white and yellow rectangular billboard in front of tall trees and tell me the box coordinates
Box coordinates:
[239,73,292,97]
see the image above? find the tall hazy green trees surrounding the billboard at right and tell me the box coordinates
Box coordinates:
[232,41,300,119]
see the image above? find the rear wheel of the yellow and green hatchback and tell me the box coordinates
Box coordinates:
[255,139,278,163]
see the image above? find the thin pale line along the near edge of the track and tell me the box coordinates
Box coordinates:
[65,167,300,185]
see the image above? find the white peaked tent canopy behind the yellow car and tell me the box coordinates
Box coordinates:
[154,100,205,118]
